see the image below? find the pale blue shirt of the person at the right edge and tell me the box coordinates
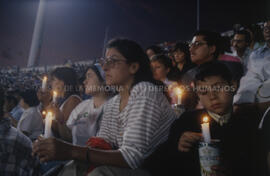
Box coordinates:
[234,44,270,104]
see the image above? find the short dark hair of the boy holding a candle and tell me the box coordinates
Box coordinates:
[195,61,232,84]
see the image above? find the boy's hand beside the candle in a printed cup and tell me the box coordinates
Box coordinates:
[178,131,202,152]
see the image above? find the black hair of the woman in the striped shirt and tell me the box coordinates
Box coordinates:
[106,38,158,86]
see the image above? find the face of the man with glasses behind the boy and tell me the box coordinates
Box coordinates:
[189,35,216,65]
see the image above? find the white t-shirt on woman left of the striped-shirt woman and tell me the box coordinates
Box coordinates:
[66,99,103,146]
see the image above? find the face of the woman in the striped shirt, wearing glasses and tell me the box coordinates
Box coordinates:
[103,48,138,86]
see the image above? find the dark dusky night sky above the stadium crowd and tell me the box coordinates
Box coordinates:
[0,0,270,67]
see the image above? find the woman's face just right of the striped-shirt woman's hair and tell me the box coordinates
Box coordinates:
[151,61,170,81]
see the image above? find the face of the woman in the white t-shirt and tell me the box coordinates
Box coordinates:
[83,69,102,95]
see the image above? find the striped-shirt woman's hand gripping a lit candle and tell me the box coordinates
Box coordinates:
[32,137,72,162]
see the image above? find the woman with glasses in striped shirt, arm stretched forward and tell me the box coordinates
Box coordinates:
[33,39,176,176]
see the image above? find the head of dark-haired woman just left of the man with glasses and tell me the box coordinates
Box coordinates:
[172,42,195,75]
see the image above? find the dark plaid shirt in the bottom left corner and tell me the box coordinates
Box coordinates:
[0,118,39,176]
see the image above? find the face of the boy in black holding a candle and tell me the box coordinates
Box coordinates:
[196,76,234,115]
